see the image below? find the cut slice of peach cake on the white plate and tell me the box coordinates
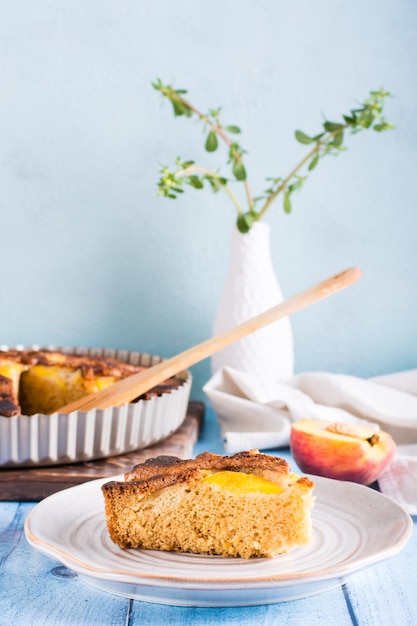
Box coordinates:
[102,450,314,558]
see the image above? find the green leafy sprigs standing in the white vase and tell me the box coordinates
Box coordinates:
[153,79,394,233]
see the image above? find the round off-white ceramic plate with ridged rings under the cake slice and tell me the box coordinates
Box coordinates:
[25,476,413,607]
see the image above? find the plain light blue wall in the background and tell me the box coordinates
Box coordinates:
[0,0,417,398]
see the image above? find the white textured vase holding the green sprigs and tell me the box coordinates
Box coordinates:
[211,222,294,380]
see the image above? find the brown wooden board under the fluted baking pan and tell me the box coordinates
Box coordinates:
[0,402,204,502]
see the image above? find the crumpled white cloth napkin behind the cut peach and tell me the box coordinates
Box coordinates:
[203,367,417,514]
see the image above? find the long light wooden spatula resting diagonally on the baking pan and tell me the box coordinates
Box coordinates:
[59,267,362,413]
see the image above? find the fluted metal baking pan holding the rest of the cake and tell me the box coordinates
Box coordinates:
[0,346,192,468]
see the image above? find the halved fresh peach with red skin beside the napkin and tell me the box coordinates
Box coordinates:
[290,419,396,485]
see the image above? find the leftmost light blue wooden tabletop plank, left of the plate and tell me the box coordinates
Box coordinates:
[0,503,130,626]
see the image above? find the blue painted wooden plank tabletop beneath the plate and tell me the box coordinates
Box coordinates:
[0,409,417,626]
